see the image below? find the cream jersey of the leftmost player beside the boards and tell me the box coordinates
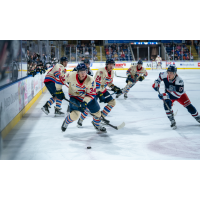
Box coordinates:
[44,63,67,85]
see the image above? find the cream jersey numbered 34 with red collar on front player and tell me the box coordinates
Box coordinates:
[56,72,96,103]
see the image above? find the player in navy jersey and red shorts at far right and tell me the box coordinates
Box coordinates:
[152,65,200,129]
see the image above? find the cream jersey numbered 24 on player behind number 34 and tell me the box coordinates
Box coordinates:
[94,67,114,93]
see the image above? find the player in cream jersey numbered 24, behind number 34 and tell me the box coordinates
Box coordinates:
[77,59,122,127]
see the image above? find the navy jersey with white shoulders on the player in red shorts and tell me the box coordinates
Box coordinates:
[156,72,185,99]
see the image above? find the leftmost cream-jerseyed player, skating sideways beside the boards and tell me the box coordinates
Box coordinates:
[41,57,68,116]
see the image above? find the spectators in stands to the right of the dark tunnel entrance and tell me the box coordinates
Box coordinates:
[165,43,193,60]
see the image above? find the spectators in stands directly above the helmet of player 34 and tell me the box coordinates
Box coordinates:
[65,43,98,62]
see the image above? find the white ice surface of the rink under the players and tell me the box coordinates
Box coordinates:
[1,70,200,160]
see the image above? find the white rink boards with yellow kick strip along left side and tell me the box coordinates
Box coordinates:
[0,74,45,138]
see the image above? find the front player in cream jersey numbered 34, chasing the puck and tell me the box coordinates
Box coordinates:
[59,63,106,132]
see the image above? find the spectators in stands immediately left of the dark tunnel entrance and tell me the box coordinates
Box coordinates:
[104,43,132,61]
